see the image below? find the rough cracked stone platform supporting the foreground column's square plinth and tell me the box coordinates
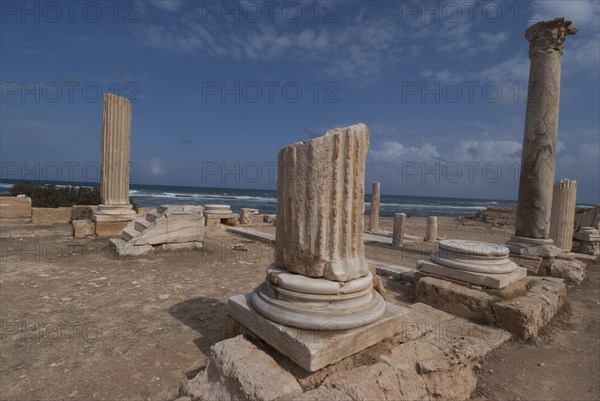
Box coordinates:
[181,303,511,401]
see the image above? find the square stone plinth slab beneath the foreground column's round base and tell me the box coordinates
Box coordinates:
[228,293,408,372]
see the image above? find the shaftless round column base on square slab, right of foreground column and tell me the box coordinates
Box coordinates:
[417,240,527,289]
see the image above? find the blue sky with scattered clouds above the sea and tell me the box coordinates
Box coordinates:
[0,0,600,203]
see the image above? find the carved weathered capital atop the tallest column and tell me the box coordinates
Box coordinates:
[525,17,578,57]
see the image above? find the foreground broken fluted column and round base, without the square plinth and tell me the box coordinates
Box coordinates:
[252,124,385,330]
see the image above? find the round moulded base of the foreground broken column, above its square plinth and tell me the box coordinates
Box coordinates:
[252,268,385,330]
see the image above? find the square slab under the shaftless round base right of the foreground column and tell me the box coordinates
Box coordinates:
[417,260,527,289]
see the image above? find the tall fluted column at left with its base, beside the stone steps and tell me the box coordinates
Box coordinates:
[94,93,136,236]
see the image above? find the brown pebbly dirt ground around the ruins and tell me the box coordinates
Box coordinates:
[0,219,600,401]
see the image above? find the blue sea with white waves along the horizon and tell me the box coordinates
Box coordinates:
[0,180,528,217]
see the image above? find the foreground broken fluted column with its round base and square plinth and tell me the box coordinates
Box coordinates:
[229,124,404,371]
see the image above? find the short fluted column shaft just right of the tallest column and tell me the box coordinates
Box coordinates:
[550,179,577,252]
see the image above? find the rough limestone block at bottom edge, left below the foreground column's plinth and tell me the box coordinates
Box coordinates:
[182,336,302,401]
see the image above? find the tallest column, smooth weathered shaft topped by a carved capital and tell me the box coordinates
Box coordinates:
[511,18,577,246]
